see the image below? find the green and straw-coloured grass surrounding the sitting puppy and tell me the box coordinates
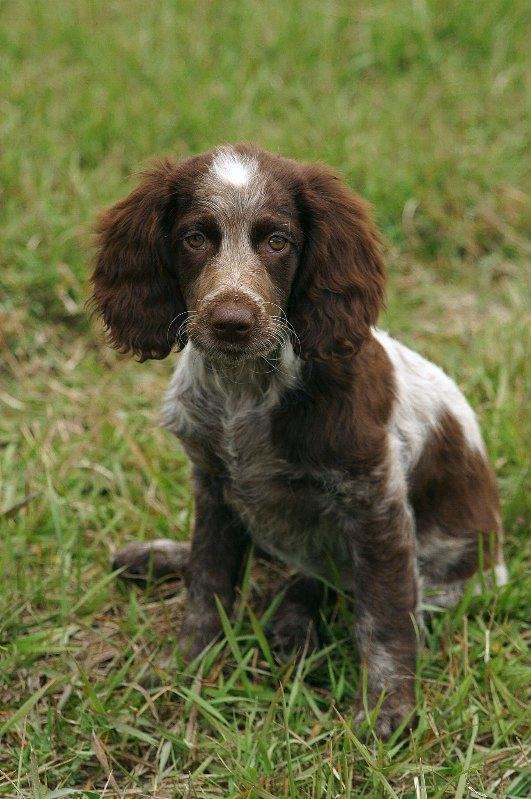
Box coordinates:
[0,0,531,799]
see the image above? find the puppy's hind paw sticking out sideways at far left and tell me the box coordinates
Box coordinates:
[111,538,190,581]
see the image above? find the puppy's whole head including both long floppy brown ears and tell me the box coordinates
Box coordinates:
[92,145,384,362]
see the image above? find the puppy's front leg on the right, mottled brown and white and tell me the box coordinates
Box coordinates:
[354,484,419,738]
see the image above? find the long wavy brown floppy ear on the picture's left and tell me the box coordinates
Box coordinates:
[89,161,185,361]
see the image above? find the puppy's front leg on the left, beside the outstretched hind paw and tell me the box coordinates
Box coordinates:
[180,469,249,660]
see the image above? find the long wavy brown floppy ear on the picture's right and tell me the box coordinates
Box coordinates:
[288,165,385,361]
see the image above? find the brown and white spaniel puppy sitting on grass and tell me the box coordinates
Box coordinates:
[92,145,505,737]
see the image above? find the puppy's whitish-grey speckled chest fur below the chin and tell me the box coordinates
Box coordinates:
[163,345,354,573]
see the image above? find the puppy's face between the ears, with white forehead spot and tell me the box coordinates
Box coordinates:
[172,149,304,361]
